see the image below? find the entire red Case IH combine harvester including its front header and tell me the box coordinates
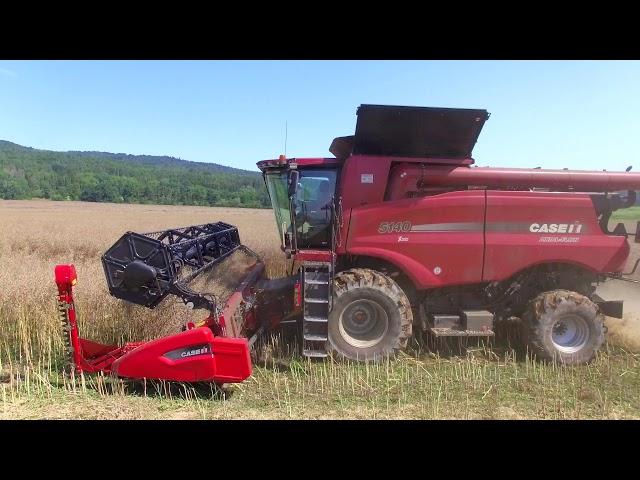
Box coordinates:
[55,105,640,383]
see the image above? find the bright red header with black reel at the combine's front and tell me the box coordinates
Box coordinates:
[55,222,278,383]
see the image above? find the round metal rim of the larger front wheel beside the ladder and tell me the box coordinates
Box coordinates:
[338,299,389,348]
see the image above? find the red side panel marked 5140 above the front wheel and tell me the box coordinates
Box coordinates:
[346,190,485,288]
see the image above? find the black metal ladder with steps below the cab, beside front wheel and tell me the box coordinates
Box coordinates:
[302,262,333,358]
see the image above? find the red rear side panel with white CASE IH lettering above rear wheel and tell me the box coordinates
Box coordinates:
[483,190,629,281]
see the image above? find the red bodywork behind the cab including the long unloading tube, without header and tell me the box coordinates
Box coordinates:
[258,150,640,289]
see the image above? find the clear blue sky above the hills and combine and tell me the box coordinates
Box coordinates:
[0,60,640,171]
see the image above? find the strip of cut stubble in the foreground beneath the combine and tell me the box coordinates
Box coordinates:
[0,347,640,419]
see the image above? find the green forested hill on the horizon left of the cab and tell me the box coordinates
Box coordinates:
[0,140,270,207]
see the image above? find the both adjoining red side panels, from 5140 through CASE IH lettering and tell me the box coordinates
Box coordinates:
[346,190,629,289]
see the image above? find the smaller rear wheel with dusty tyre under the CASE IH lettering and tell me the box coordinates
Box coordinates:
[523,290,607,365]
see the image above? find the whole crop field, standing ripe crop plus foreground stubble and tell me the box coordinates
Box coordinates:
[0,200,640,419]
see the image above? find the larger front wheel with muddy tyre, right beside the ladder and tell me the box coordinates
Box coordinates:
[329,268,413,361]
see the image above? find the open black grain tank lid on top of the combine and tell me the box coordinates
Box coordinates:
[329,105,489,159]
